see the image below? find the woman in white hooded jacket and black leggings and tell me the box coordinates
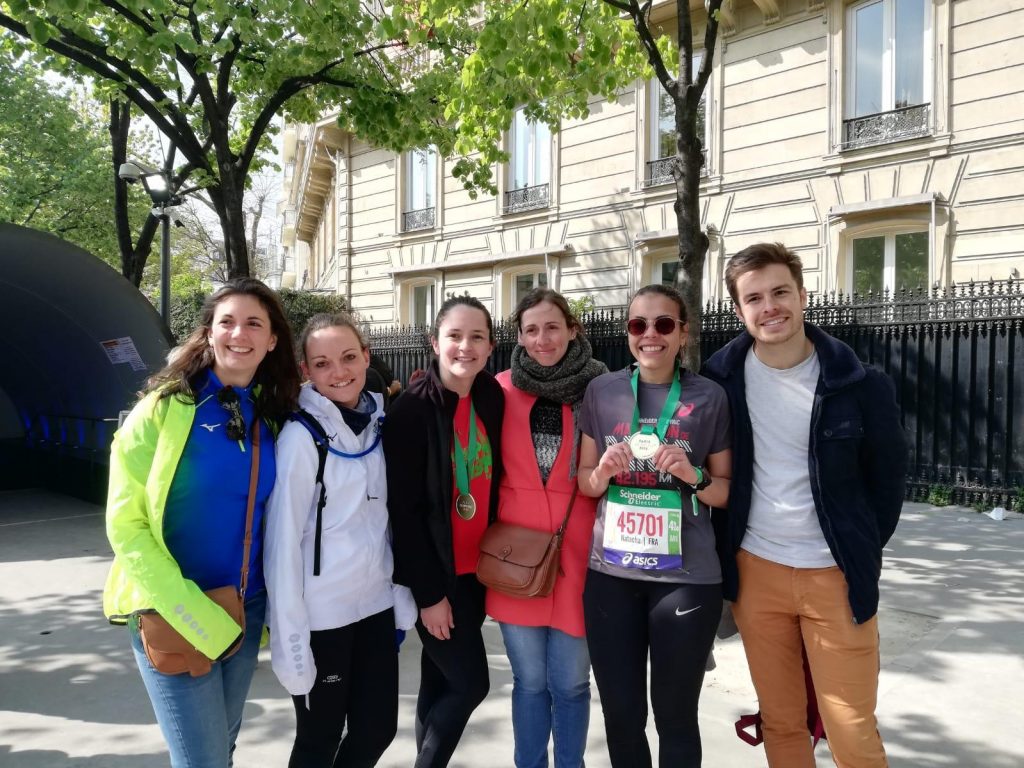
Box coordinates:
[264,314,416,768]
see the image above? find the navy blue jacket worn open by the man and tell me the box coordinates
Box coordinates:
[702,323,907,624]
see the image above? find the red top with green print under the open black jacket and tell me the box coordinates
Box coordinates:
[452,397,494,575]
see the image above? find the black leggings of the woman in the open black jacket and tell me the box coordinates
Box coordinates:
[416,573,490,768]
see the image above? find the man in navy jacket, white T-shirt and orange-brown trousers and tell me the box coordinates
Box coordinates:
[703,244,906,768]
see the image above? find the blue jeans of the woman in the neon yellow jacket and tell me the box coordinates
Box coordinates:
[130,591,266,768]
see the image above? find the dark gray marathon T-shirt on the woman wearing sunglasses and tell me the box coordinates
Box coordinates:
[580,367,731,584]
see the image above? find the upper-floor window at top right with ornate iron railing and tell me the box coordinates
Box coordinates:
[843,0,931,148]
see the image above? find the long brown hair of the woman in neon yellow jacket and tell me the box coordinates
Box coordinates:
[143,278,299,420]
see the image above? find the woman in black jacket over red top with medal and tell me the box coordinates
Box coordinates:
[383,296,504,768]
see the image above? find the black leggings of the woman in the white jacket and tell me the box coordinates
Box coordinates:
[288,608,398,768]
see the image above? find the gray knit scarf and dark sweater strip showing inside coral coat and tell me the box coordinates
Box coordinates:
[512,335,608,478]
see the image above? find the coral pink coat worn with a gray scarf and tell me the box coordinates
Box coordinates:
[486,371,597,637]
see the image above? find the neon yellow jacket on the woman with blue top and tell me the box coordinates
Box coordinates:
[103,392,243,658]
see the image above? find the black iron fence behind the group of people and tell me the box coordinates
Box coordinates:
[371,280,1024,506]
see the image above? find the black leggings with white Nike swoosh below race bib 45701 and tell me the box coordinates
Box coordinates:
[583,570,722,768]
